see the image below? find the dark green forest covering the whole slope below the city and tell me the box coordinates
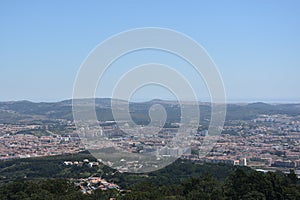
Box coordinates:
[0,152,300,200]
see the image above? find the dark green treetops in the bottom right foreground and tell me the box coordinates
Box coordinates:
[121,168,300,200]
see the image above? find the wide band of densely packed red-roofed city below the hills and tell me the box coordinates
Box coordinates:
[0,114,300,171]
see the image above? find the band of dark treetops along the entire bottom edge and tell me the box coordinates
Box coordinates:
[0,168,300,200]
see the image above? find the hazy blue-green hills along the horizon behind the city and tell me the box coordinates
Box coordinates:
[0,98,300,124]
